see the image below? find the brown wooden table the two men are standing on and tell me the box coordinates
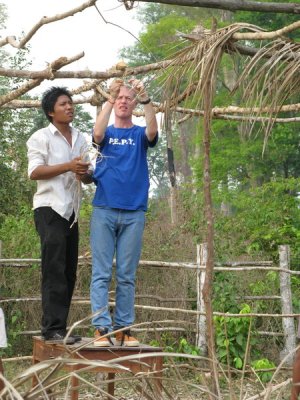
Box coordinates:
[33,336,163,400]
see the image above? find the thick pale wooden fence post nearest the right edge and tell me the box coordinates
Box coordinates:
[279,245,296,365]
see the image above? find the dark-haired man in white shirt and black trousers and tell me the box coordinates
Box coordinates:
[27,87,90,344]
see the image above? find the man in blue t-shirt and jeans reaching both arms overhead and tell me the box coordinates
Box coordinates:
[91,79,158,347]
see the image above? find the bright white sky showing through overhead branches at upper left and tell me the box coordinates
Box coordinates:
[0,0,141,93]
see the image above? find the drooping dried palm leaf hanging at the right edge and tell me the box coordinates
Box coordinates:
[237,39,300,147]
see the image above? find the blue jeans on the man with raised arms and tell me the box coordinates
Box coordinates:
[90,207,145,331]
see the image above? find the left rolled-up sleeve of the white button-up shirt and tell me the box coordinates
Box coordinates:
[26,132,48,177]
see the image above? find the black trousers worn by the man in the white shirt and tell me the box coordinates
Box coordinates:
[34,207,79,336]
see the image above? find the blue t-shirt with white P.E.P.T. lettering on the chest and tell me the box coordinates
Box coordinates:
[93,125,158,211]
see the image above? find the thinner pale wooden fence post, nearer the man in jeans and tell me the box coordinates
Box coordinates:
[196,243,207,355]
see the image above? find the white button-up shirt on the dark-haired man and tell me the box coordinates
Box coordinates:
[27,123,89,220]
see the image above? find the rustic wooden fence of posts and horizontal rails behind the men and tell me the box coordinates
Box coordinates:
[0,242,300,364]
